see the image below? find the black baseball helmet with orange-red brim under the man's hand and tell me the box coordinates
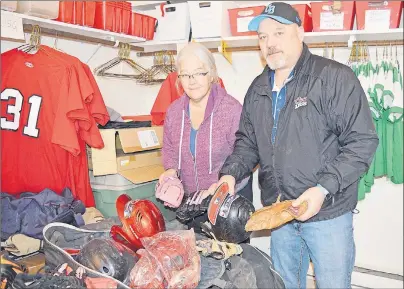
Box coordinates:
[208,183,255,243]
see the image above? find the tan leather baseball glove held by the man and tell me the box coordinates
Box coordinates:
[245,196,307,232]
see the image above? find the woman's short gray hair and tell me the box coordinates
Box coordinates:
[176,42,219,88]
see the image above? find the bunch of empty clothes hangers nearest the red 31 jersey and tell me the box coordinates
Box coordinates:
[94,43,146,79]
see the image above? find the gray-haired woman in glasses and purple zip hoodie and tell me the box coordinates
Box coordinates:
[159,43,252,231]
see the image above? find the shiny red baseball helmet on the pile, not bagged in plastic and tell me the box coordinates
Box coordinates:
[111,194,166,251]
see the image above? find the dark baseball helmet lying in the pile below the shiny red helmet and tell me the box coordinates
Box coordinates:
[76,238,138,282]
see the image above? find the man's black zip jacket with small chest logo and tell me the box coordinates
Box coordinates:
[220,44,379,221]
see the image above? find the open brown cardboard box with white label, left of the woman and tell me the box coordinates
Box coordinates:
[90,126,164,184]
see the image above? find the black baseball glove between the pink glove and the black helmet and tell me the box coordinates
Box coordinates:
[176,191,212,223]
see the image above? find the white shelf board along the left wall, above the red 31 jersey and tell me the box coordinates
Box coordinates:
[1,10,145,44]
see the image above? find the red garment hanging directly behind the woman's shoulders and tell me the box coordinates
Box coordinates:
[150,72,225,125]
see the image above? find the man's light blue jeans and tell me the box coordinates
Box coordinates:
[271,212,355,289]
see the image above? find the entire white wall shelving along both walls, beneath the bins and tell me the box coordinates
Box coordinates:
[1,10,403,52]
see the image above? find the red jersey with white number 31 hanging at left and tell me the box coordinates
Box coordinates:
[1,49,108,207]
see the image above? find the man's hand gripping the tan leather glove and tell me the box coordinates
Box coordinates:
[292,187,325,222]
